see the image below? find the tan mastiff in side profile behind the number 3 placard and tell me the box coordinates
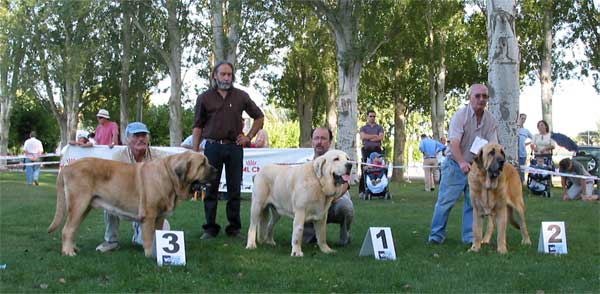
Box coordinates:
[48,152,216,257]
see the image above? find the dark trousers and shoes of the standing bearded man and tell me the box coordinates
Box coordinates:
[202,142,244,236]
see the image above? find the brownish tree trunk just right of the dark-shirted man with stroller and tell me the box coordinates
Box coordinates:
[392,94,406,182]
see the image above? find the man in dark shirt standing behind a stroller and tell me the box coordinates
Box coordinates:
[358,110,383,199]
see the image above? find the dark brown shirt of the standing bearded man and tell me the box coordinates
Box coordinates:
[194,88,264,141]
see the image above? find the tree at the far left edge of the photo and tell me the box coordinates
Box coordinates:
[0,1,28,163]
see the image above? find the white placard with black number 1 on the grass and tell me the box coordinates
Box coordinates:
[358,227,396,260]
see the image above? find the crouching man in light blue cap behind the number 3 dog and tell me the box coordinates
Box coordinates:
[96,122,169,252]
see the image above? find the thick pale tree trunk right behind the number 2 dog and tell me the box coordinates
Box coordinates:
[487,0,519,161]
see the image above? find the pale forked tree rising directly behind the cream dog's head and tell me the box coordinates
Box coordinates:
[303,0,399,159]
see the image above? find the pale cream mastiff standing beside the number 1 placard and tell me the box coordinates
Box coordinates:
[246,150,352,256]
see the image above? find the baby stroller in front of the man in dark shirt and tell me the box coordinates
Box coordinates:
[363,152,392,200]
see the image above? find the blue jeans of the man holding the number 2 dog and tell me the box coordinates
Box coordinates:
[429,158,473,244]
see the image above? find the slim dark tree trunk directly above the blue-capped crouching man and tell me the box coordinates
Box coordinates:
[119,1,131,142]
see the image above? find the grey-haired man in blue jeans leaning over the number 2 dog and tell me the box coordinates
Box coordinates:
[428,84,498,244]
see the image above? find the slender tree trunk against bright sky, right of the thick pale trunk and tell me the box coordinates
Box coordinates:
[540,0,553,130]
